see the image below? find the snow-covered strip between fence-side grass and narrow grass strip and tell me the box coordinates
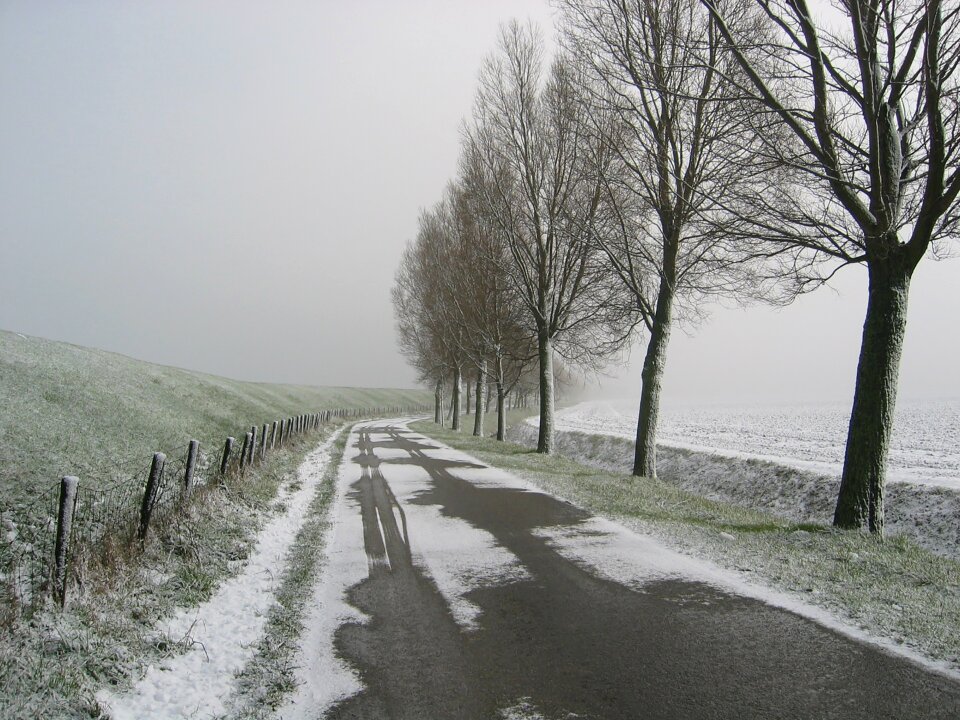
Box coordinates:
[97,433,339,720]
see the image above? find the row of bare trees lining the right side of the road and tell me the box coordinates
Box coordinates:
[395,0,960,534]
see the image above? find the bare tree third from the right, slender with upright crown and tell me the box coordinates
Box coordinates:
[466,22,628,453]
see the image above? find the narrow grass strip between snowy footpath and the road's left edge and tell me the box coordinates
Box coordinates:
[230,432,349,718]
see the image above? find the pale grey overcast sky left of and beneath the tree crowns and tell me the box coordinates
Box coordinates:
[0,0,960,402]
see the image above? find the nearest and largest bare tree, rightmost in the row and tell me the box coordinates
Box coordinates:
[701,0,960,534]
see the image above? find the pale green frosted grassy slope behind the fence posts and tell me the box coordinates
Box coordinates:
[0,331,432,508]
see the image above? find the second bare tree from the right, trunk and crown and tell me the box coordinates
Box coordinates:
[560,0,784,477]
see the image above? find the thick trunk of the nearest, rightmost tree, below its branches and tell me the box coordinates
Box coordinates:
[833,251,913,535]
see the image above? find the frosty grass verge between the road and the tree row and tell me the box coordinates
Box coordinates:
[411,421,960,669]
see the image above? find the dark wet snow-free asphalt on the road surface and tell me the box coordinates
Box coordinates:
[317,423,960,720]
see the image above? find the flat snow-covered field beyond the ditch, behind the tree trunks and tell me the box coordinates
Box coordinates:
[557,400,960,489]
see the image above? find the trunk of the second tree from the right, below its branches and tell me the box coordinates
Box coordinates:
[633,278,674,478]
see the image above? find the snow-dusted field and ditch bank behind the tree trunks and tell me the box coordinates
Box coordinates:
[514,402,960,558]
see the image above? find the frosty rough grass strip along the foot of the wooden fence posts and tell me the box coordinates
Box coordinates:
[0,426,331,718]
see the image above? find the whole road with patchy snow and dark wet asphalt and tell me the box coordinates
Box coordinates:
[278,422,960,720]
